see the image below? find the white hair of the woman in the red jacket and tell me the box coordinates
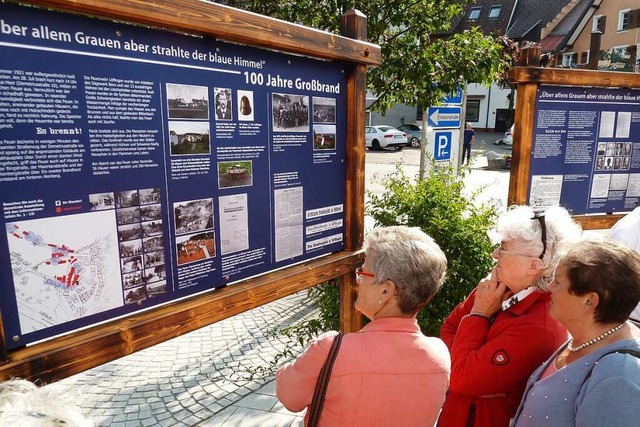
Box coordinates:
[496,206,582,291]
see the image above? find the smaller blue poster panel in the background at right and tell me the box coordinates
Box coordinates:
[528,85,640,214]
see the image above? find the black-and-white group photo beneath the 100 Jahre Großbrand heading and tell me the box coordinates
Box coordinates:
[271,93,309,132]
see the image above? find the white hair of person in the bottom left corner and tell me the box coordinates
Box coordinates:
[0,379,94,427]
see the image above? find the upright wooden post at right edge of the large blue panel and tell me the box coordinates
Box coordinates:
[340,10,368,333]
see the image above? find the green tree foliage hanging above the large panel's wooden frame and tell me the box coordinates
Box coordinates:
[228,0,511,111]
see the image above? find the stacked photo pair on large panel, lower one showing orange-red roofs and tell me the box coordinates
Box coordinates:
[173,199,216,265]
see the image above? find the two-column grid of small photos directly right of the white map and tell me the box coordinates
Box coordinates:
[110,188,167,304]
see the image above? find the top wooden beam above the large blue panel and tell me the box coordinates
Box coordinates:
[22,0,381,66]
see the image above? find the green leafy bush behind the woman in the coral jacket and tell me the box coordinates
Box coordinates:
[367,167,497,336]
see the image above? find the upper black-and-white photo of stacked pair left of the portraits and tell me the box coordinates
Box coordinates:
[167,83,209,120]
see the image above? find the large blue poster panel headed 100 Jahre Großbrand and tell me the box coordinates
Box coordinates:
[0,4,346,348]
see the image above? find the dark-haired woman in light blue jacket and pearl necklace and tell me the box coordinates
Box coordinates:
[512,240,640,427]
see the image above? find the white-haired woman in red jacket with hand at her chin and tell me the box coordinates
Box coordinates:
[438,206,581,427]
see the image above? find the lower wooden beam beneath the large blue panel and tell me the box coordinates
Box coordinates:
[0,251,364,382]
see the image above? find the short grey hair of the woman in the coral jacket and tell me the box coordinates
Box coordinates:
[364,226,447,314]
